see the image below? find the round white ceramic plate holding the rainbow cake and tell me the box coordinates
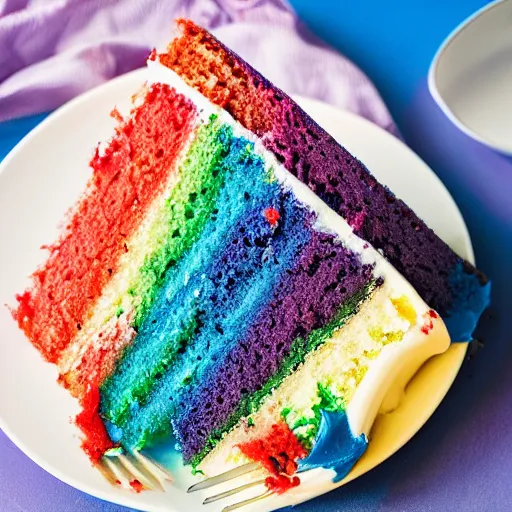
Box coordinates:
[0,71,473,512]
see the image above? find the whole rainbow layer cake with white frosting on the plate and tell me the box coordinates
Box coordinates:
[14,20,489,491]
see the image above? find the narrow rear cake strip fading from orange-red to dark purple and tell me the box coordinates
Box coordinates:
[162,20,490,341]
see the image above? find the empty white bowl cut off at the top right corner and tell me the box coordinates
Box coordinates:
[428,0,512,155]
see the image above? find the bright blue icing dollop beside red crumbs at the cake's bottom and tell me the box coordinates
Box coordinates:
[299,409,368,482]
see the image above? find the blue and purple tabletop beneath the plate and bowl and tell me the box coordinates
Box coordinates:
[4,0,512,512]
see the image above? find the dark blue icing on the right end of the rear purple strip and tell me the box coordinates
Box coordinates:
[443,262,491,342]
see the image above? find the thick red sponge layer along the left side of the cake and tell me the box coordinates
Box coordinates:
[14,84,196,362]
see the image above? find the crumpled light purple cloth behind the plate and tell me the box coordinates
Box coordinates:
[0,0,394,131]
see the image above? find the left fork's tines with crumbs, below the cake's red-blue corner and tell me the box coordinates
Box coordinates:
[99,448,172,491]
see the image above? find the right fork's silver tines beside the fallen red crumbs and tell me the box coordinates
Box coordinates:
[187,462,289,512]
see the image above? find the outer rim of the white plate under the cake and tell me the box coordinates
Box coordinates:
[0,68,474,512]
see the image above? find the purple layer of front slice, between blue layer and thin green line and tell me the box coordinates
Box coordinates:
[173,232,373,461]
